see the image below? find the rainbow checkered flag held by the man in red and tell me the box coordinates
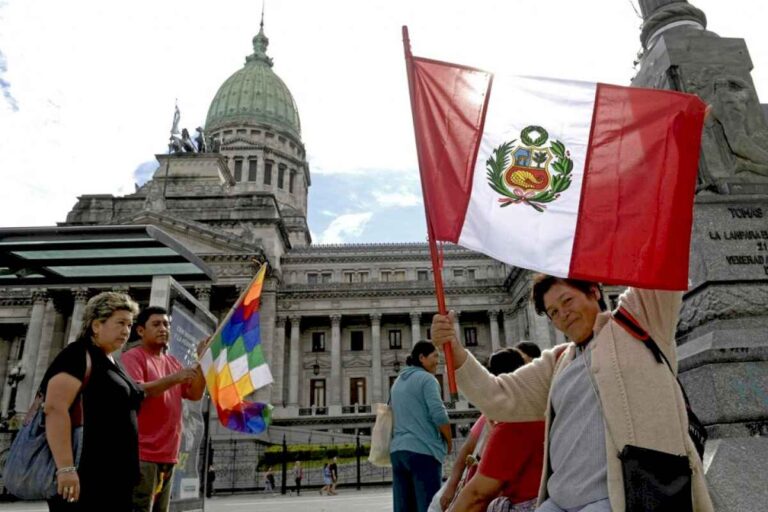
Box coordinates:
[200,263,272,434]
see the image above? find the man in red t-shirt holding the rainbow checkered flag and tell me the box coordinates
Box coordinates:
[121,306,205,512]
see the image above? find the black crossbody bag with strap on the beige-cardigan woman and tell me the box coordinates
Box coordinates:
[613,308,707,512]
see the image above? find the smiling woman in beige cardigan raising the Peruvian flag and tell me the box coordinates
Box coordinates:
[432,274,713,512]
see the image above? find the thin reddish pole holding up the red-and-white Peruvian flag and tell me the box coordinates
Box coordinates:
[403,26,459,401]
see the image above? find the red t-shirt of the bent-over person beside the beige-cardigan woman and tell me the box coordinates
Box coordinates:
[478,421,544,503]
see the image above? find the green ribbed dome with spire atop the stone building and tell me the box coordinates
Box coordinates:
[205,23,301,141]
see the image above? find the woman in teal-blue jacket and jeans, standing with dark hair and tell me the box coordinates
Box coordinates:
[390,341,451,512]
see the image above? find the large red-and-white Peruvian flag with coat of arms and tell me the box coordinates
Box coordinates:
[408,55,706,290]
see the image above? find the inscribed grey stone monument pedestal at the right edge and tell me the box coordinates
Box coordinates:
[678,194,768,512]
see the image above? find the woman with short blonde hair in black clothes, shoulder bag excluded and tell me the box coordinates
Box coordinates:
[40,292,144,512]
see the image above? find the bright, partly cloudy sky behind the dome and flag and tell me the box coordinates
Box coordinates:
[0,0,768,243]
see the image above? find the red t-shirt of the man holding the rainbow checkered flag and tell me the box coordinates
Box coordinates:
[120,346,188,464]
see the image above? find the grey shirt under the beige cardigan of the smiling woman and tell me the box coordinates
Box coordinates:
[547,350,608,509]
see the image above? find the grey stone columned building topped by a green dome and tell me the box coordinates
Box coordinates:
[0,22,557,488]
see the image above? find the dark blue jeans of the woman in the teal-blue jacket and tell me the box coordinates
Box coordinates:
[390,451,443,512]
